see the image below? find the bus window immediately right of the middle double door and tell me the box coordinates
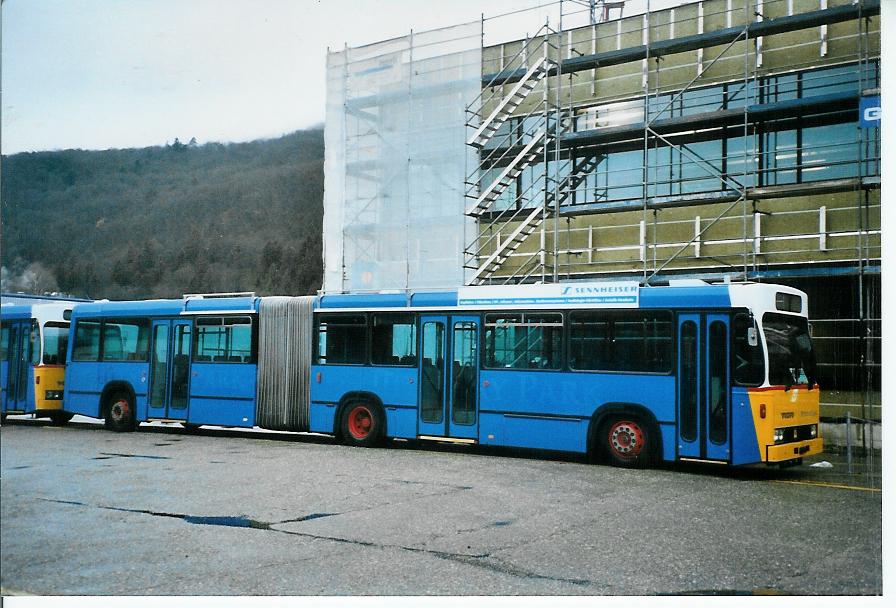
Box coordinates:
[485,313,563,369]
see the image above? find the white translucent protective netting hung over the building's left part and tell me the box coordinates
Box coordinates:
[323,22,482,292]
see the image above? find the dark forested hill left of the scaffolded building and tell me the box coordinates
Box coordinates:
[0,129,324,299]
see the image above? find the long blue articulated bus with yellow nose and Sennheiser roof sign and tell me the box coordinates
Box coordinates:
[65,281,822,466]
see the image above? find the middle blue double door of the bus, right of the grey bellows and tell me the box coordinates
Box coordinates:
[417,316,479,439]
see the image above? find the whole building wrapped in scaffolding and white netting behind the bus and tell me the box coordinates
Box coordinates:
[324,0,881,420]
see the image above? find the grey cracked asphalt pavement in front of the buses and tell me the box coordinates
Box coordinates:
[0,417,882,595]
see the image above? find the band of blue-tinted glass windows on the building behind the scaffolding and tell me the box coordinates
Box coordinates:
[481,62,880,211]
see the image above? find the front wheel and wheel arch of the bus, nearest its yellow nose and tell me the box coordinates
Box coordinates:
[588,403,663,468]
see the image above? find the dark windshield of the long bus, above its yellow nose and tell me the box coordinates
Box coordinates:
[762,313,816,388]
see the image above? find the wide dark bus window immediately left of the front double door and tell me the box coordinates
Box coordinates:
[569,311,672,373]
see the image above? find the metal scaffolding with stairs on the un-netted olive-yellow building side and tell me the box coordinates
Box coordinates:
[464,0,880,430]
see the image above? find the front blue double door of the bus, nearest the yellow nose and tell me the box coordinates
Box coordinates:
[678,314,731,461]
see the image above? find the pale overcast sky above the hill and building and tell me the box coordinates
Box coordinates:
[2,0,678,154]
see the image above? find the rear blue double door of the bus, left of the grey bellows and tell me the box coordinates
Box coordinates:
[147,320,192,421]
